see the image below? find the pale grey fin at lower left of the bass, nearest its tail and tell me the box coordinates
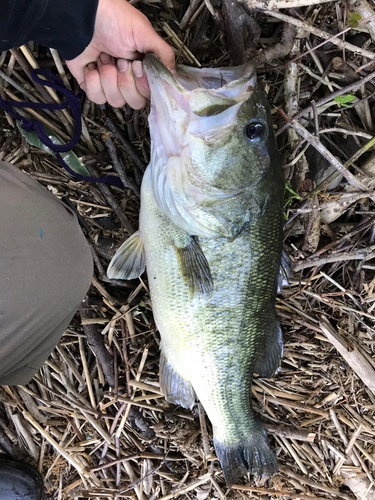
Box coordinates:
[159,353,195,408]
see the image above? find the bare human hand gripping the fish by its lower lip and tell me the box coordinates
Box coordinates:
[66,0,175,109]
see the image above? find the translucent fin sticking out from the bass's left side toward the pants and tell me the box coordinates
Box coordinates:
[107,231,146,280]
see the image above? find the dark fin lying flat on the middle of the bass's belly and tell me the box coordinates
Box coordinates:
[176,237,213,295]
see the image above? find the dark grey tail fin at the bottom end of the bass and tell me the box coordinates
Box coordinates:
[214,418,278,488]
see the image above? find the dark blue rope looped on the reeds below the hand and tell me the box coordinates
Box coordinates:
[0,69,124,189]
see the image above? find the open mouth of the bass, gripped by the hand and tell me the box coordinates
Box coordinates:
[143,53,257,116]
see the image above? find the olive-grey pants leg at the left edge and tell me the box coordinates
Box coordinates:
[0,161,93,385]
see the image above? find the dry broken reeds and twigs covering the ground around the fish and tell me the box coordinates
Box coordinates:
[0,0,375,500]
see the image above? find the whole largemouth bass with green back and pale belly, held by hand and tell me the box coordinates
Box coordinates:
[108,55,284,486]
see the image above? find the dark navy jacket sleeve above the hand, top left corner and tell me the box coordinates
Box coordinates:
[0,0,98,60]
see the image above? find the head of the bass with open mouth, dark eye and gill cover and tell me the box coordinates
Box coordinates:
[144,54,283,238]
